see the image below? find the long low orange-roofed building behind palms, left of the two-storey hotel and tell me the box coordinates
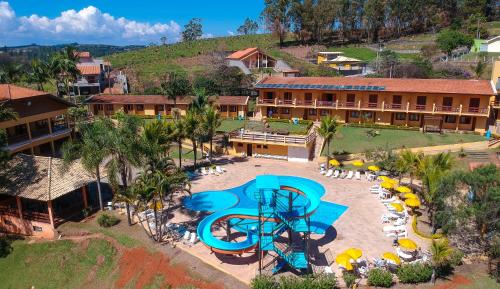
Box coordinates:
[86,94,249,118]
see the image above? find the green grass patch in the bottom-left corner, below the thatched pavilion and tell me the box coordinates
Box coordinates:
[0,236,116,289]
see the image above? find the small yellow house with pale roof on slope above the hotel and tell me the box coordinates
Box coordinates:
[317,51,365,75]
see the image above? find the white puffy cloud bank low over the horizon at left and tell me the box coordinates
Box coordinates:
[0,2,181,45]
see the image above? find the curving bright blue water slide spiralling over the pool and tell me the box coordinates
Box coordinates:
[197,175,324,254]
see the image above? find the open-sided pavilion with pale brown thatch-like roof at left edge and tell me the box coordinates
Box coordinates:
[0,154,106,239]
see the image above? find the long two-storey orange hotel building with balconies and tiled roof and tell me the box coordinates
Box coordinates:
[255,77,496,132]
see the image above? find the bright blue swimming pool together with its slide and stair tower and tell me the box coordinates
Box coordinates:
[184,175,347,272]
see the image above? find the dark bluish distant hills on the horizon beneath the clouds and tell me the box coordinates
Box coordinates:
[0,43,145,60]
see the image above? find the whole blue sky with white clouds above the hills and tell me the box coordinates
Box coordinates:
[0,0,264,46]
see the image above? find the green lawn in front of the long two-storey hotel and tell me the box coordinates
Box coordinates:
[323,126,484,154]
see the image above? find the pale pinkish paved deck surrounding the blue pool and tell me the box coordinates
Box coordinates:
[172,158,430,283]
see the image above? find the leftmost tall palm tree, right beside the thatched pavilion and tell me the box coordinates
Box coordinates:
[61,119,112,211]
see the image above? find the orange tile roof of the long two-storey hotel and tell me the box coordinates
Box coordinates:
[257,77,496,96]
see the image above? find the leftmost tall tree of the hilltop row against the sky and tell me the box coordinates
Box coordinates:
[262,0,293,47]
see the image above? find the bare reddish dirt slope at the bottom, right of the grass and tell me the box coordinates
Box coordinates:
[115,247,223,289]
